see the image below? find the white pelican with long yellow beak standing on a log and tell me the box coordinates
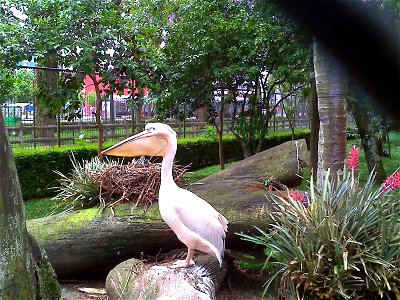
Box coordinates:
[102,123,228,268]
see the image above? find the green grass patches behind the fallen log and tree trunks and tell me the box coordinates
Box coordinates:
[25,132,400,220]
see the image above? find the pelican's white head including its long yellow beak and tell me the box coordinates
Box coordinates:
[101,123,176,157]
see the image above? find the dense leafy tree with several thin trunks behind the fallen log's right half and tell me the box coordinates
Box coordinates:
[155,1,309,162]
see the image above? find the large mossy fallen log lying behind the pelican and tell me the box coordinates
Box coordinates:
[27,141,306,278]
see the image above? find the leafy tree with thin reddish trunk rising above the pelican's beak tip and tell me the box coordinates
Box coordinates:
[9,0,158,154]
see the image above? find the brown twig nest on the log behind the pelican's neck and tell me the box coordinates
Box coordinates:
[92,159,187,208]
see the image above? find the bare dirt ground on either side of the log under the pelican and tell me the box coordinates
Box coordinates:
[61,268,268,300]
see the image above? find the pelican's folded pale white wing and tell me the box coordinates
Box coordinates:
[175,189,228,256]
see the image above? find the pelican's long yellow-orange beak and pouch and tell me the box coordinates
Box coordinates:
[101,130,168,157]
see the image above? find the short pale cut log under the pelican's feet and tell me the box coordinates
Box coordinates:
[106,251,228,300]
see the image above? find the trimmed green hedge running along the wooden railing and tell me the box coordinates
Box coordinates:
[14,130,310,199]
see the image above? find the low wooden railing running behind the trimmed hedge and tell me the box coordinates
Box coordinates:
[7,119,310,148]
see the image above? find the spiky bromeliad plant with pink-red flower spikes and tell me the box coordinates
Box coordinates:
[241,148,400,299]
